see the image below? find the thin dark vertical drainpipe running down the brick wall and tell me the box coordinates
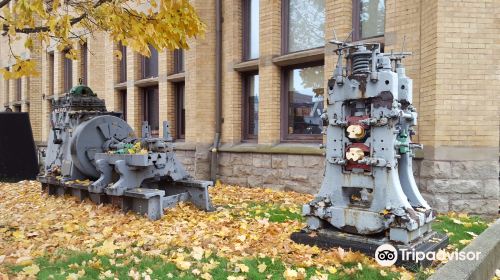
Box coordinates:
[210,0,222,183]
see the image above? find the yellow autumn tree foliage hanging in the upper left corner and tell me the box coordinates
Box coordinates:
[0,0,205,78]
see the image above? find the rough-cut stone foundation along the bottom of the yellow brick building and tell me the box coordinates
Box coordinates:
[176,148,500,216]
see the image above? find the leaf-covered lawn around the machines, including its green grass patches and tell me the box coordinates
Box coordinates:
[0,182,487,279]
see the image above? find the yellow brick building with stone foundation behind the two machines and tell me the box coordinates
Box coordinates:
[0,0,500,214]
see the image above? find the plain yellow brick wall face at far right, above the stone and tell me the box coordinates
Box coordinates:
[434,0,500,147]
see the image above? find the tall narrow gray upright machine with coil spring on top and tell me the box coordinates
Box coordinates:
[292,41,447,266]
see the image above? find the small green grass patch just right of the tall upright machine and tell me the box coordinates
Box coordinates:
[432,213,488,250]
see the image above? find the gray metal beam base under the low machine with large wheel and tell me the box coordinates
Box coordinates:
[37,176,213,220]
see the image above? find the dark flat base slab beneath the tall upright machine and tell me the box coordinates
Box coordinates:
[291,228,448,270]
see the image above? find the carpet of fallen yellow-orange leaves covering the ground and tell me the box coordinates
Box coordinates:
[0,181,410,280]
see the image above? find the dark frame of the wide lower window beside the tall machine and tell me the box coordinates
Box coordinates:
[280,59,327,143]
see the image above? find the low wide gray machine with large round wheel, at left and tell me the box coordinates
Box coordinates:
[38,86,213,219]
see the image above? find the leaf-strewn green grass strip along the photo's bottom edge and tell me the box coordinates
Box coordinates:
[5,251,399,280]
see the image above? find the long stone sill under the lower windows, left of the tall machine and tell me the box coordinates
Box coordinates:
[219,143,324,155]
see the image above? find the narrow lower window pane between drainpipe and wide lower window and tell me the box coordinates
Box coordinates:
[246,75,259,136]
